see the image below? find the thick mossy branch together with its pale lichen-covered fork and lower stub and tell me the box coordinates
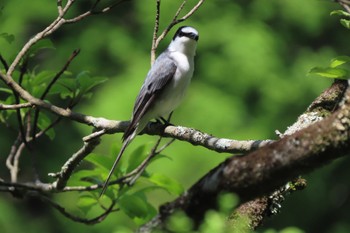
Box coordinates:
[139,80,350,232]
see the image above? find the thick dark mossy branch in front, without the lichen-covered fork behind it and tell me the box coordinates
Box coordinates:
[156,86,350,226]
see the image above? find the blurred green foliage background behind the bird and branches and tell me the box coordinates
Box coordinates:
[0,0,350,233]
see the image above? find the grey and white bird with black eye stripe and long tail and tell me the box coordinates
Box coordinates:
[100,26,199,197]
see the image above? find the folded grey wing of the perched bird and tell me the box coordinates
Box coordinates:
[123,52,177,140]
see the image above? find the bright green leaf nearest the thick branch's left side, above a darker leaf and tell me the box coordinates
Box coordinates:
[148,173,184,195]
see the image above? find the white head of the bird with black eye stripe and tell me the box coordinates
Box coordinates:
[169,26,199,55]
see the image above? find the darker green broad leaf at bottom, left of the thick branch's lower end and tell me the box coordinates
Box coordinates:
[118,192,157,225]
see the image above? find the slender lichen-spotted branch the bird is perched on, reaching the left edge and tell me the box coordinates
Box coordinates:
[0,71,271,153]
